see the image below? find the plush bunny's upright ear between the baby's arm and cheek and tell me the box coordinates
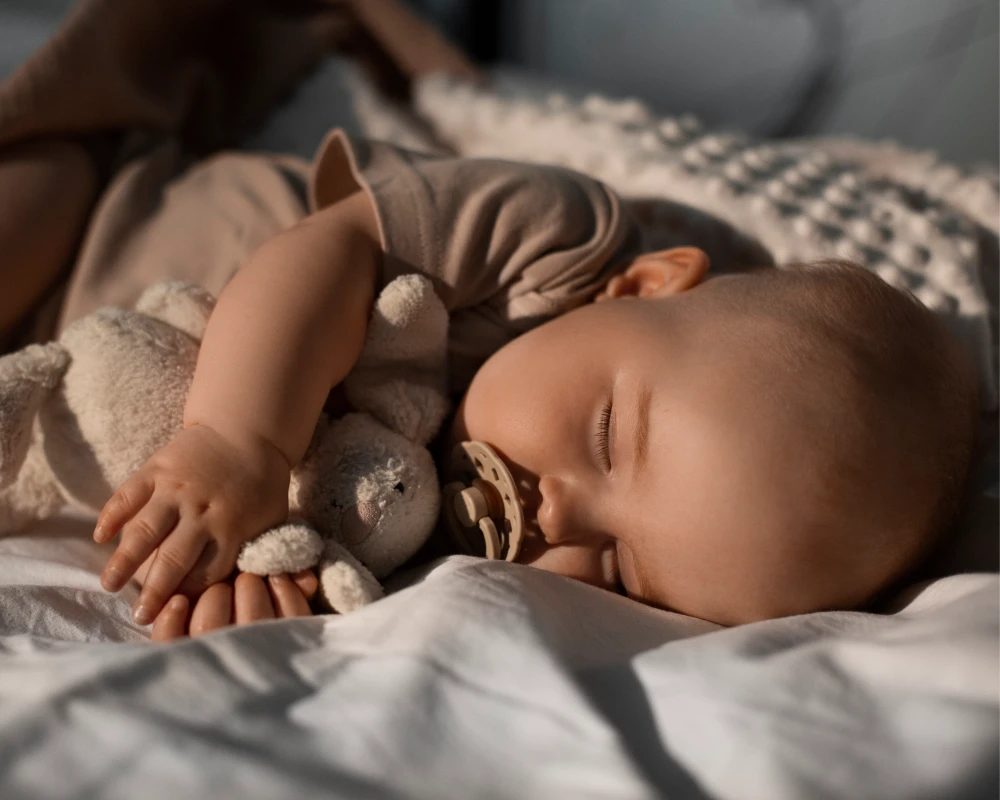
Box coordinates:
[344,275,448,445]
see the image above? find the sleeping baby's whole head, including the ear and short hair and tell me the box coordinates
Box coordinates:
[452,248,978,624]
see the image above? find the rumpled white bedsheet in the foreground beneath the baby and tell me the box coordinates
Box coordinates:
[0,519,1000,800]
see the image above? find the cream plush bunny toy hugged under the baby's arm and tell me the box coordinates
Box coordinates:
[0,275,448,612]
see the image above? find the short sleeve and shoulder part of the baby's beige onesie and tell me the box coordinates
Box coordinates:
[310,130,639,394]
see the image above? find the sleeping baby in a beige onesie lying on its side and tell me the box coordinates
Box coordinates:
[0,7,978,638]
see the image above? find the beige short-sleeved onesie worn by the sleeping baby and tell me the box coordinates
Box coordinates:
[35,130,639,400]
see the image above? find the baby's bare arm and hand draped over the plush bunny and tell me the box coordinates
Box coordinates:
[94,192,381,624]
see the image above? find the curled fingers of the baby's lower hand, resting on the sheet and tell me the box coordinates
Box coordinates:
[145,569,319,642]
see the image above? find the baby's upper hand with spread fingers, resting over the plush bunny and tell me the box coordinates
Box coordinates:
[94,425,289,625]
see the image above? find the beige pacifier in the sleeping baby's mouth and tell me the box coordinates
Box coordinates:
[442,442,524,561]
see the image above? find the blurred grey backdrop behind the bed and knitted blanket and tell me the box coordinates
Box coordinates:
[0,0,1000,167]
